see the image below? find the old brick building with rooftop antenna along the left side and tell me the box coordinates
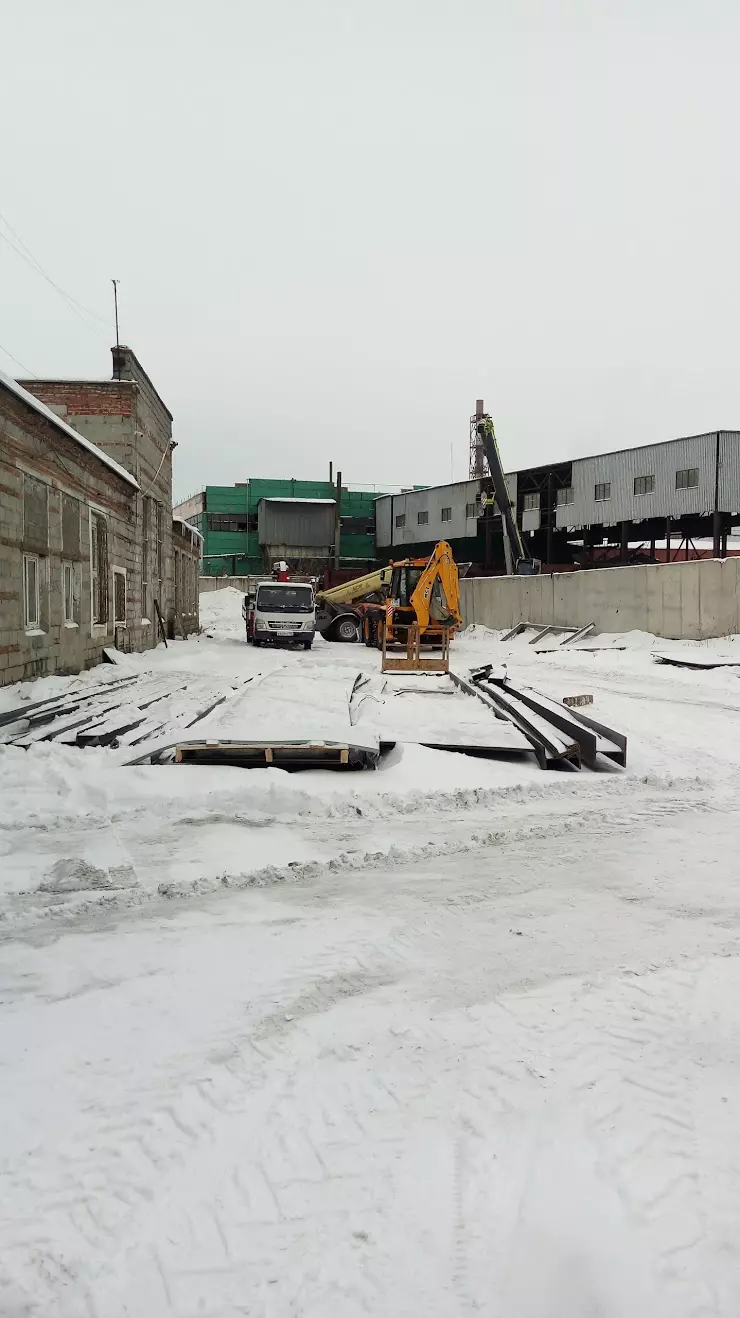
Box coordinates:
[0,347,199,683]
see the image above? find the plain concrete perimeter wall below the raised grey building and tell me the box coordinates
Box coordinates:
[460,558,740,641]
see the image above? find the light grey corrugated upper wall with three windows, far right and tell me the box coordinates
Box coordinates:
[557,431,740,527]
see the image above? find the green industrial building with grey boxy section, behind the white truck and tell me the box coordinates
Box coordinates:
[174,478,387,576]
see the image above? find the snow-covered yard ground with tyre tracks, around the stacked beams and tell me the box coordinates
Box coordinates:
[0,589,740,1318]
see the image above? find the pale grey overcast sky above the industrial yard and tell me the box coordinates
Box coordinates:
[0,0,740,496]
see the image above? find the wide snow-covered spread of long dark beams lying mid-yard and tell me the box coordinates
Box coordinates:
[0,664,627,770]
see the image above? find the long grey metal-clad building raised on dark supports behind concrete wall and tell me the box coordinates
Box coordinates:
[376,430,740,571]
